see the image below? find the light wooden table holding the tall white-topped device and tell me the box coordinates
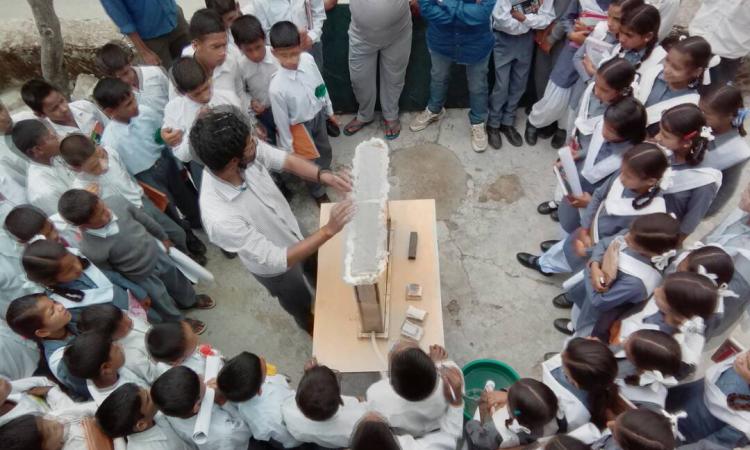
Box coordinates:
[313,199,444,372]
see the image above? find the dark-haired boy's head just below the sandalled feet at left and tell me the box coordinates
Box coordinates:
[146,320,198,366]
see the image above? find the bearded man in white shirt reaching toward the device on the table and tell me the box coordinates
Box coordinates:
[190,111,354,332]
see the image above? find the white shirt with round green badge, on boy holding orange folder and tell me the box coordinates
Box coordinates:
[268,53,333,150]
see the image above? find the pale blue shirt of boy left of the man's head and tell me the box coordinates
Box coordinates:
[101,105,163,176]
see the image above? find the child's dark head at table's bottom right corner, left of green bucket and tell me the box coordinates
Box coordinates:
[388,339,438,402]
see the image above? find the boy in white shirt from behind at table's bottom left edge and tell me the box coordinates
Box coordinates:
[281,359,367,448]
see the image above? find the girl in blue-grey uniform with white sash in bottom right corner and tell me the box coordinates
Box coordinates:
[667,352,750,448]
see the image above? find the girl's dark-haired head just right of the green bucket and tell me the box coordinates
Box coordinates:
[506,378,557,430]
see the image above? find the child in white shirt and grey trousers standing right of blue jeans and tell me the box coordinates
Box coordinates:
[488,0,555,150]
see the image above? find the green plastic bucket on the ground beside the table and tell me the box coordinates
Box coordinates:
[461,359,521,420]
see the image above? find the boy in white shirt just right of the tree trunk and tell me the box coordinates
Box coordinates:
[96,42,169,111]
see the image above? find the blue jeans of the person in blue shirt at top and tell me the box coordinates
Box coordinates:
[427,51,490,125]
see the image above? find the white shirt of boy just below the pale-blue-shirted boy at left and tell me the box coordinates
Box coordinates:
[71,148,143,208]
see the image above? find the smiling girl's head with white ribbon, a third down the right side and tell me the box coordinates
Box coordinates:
[656,103,713,166]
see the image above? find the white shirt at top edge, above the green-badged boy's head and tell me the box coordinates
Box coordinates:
[254,0,326,42]
